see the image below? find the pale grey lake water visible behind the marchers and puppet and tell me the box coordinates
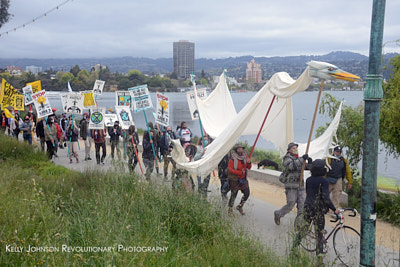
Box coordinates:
[49,91,400,181]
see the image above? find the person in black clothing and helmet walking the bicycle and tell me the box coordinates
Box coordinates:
[293,159,339,256]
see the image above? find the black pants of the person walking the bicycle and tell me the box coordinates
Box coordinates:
[294,206,325,255]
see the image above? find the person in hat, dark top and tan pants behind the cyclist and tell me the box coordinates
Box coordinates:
[326,146,353,207]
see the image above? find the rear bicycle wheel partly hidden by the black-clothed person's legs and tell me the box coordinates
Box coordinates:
[294,213,317,252]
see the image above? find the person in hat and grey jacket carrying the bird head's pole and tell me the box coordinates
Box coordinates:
[274,142,312,225]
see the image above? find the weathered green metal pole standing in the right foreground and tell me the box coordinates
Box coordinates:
[360,0,386,267]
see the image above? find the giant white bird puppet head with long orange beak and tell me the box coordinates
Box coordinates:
[307,61,361,82]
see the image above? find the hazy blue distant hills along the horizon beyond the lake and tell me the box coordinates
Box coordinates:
[0,51,397,78]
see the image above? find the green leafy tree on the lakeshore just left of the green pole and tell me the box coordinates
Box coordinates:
[316,93,364,169]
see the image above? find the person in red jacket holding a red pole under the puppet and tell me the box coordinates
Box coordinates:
[228,144,251,215]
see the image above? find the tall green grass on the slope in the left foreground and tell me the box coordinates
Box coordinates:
[0,135,318,266]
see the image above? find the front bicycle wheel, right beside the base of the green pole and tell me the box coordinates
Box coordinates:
[333,225,360,266]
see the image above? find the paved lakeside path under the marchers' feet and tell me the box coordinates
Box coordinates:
[53,141,399,266]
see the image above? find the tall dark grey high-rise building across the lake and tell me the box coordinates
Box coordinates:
[173,40,194,79]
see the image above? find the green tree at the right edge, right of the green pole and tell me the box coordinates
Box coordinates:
[379,56,400,158]
